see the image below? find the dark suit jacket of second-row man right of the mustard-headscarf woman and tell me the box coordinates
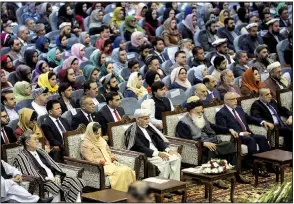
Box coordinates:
[41,116,72,149]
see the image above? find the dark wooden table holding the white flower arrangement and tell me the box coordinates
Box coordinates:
[182,169,236,203]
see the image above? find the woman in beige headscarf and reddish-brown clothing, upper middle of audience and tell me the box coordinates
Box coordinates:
[161,18,182,47]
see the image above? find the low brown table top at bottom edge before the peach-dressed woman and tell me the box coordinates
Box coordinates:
[82,189,128,203]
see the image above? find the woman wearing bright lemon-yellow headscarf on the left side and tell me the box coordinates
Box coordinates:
[38,72,58,94]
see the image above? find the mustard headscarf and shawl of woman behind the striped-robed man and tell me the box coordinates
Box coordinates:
[17,108,44,138]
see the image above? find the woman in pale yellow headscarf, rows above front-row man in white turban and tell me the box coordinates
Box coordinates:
[124,72,148,100]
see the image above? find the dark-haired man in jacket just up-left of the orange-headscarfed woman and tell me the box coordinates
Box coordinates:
[231,50,249,77]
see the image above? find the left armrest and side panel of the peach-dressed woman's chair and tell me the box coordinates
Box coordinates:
[63,156,105,190]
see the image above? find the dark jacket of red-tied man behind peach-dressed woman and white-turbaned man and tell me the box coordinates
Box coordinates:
[98,105,125,135]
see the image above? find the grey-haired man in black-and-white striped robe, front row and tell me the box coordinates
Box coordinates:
[13,130,85,202]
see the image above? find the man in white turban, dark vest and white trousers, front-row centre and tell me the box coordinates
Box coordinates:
[125,109,181,180]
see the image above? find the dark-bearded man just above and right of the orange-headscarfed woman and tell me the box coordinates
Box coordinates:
[253,44,274,73]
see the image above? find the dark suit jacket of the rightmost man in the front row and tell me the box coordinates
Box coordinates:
[250,99,292,123]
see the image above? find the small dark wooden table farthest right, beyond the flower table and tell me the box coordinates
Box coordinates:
[253,149,293,186]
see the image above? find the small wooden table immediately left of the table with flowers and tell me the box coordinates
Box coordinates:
[146,177,187,203]
